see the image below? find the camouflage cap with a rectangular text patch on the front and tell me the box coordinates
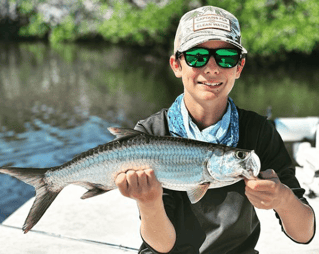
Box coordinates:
[174,6,247,54]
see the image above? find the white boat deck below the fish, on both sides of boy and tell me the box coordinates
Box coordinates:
[0,186,319,254]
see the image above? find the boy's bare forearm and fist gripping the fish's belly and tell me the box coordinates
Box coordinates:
[115,169,176,253]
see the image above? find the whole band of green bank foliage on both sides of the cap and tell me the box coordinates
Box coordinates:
[10,0,319,55]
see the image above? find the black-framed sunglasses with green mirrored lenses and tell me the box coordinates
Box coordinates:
[176,48,242,68]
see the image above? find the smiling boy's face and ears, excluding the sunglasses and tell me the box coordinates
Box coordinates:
[170,41,245,105]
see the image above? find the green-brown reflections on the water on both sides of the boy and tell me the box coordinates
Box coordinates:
[0,43,319,132]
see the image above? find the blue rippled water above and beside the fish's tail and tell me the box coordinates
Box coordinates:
[0,116,116,222]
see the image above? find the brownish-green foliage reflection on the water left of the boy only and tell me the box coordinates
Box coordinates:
[0,43,181,134]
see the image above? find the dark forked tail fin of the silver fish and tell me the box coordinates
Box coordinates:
[0,167,61,233]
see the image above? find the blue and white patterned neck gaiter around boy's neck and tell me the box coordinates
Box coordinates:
[167,94,239,147]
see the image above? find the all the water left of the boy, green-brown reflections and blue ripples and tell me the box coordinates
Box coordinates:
[0,43,182,222]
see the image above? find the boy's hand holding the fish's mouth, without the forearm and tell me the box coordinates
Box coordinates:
[245,169,290,210]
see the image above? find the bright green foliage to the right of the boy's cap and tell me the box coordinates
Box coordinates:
[202,0,319,56]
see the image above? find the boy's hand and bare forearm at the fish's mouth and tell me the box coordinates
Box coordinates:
[245,169,315,243]
